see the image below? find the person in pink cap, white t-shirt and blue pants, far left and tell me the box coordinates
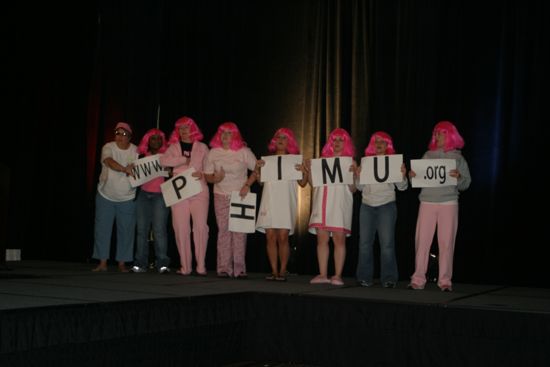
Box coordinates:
[92,122,138,272]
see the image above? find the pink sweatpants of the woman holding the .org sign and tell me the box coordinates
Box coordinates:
[411,202,458,286]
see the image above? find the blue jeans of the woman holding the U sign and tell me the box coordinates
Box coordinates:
[356,201,399,284]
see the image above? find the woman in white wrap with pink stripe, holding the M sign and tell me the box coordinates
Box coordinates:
[307,128,356,285]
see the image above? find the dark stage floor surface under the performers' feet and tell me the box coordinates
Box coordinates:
[0,260,550,313]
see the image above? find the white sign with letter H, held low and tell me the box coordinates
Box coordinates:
[229,191,256,233]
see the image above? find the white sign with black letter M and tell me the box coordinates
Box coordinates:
[311,157,353,187]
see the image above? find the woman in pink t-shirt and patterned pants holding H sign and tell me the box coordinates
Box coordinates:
[204,122,256,278]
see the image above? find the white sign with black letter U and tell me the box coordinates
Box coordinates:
[359,154,403,185]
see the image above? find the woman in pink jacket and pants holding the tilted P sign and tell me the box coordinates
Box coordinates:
[160,116,210,276]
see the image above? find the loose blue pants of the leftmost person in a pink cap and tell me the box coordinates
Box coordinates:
[92,193,136,262]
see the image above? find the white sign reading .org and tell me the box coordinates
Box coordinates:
[411,159,456,187]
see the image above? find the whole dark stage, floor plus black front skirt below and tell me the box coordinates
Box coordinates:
[0,264,550,367]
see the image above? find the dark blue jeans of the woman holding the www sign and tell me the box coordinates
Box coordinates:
[134,190,170,268]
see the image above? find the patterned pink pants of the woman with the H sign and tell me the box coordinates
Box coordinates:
[214,194,246,276]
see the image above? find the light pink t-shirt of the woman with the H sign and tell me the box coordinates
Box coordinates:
[204,147,256,195]
